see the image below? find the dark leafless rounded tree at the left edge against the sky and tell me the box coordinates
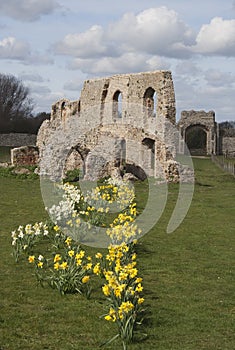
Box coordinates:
[0,73,33,132]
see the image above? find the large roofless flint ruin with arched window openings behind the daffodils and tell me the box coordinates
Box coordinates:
[37,71,191,182]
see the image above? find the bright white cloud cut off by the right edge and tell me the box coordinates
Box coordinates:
[193,17,235,56]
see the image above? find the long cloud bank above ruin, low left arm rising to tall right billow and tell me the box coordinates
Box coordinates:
[53,6,195,58]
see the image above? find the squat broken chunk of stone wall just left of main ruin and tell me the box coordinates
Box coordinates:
[11,146,39,166]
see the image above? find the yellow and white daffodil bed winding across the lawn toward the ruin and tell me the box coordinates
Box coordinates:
[12,180,147,349]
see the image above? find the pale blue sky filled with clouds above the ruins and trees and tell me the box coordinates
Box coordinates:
[0,0,235,122]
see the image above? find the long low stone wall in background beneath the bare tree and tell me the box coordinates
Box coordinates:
[0,133,37,147]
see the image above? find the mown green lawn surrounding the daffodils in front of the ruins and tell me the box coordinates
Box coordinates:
[0,158,235,350]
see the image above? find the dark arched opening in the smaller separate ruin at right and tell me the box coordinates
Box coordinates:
[185,125,207,155]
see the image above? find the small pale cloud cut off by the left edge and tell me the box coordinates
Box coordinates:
[0,36,30,60]
